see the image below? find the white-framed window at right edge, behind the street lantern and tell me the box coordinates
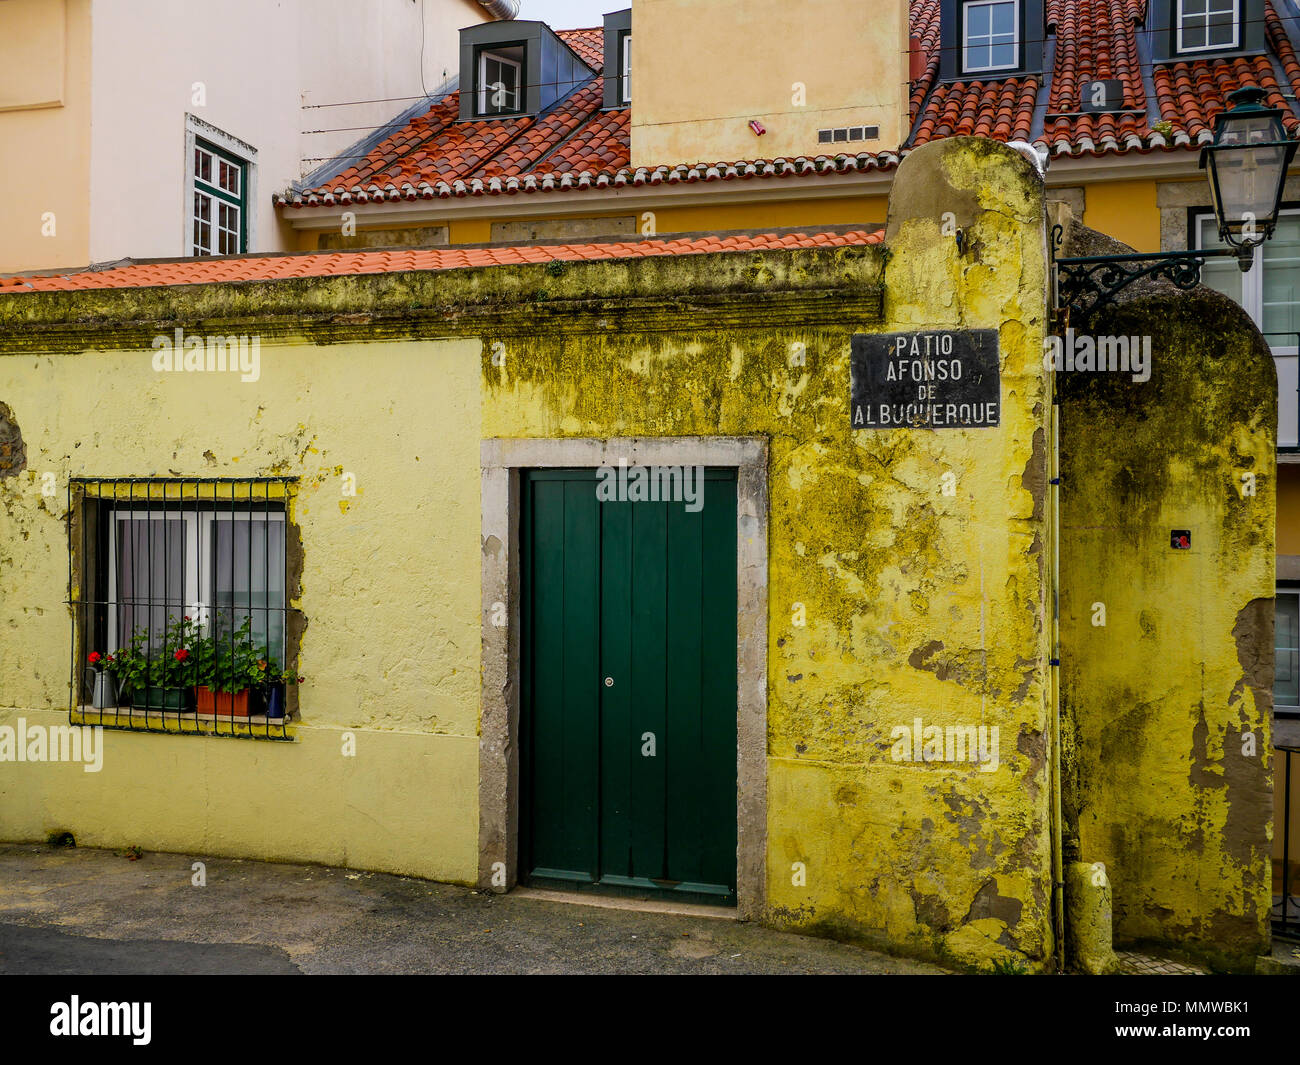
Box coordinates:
[1192,208,1300,449]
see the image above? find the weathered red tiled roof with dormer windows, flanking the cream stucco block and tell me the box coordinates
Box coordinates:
[277,0,1300,208]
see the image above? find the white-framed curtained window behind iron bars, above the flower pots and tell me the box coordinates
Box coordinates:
[105,503,286,662]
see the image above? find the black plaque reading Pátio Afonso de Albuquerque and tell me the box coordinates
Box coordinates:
[849,329,1002,429]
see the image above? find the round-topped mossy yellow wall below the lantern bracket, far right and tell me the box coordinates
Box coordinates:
[1058,279,1277,970]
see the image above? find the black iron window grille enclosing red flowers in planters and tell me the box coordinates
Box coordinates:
[68,477,302,740]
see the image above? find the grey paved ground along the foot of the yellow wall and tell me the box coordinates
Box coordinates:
[0,844,944,974]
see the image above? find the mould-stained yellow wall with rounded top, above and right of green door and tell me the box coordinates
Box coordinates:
[482,139,1050,967]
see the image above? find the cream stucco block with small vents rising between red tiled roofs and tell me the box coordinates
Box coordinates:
[632,0,909,166]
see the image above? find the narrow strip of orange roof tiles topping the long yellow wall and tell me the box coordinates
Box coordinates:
[0,229,884,295]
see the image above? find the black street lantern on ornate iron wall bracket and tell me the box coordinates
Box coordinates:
[1052,87,1297,311]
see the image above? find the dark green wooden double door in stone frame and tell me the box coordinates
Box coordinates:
[520,469,736,902]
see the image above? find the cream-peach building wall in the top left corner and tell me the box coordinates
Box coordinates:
[0,0,91,273]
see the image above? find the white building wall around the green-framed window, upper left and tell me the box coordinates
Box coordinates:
[89,0,488,265]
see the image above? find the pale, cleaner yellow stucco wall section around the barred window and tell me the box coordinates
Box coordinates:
[0,337,480,882]
